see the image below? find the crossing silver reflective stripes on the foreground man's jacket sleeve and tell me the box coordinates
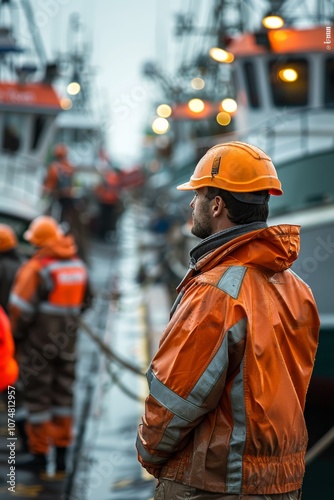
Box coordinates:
[147,318,247,451]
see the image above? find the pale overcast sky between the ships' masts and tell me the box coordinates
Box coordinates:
[30,0,192,167]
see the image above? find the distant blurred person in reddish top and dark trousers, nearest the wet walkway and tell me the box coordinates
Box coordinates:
[95,168,122,241]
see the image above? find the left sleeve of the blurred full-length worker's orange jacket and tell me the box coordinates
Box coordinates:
[9,262,40,340]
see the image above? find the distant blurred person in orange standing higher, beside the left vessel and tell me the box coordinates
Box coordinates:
[44,144,75,222]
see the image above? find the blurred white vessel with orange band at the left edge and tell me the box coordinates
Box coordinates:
[0,1,61,252]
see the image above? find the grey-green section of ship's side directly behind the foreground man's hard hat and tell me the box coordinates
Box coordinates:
[270,151,334,216]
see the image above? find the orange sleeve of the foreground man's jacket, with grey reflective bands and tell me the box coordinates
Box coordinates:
[137,284,246,476]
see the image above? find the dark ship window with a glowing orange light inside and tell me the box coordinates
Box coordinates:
[268,57,309,107]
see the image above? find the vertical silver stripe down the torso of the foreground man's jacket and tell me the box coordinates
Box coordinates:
[226,362,246,494]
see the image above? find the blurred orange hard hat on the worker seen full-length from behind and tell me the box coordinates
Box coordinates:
[23,215,63,247]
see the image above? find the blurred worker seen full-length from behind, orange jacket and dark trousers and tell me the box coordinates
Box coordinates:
[10,216,91,474]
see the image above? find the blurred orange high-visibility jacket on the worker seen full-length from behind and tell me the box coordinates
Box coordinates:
[9,236,89,339]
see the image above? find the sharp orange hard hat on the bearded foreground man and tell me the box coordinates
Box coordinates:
[177,141,283,201]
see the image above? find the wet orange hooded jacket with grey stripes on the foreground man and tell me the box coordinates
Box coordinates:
[137,225,319,495]
